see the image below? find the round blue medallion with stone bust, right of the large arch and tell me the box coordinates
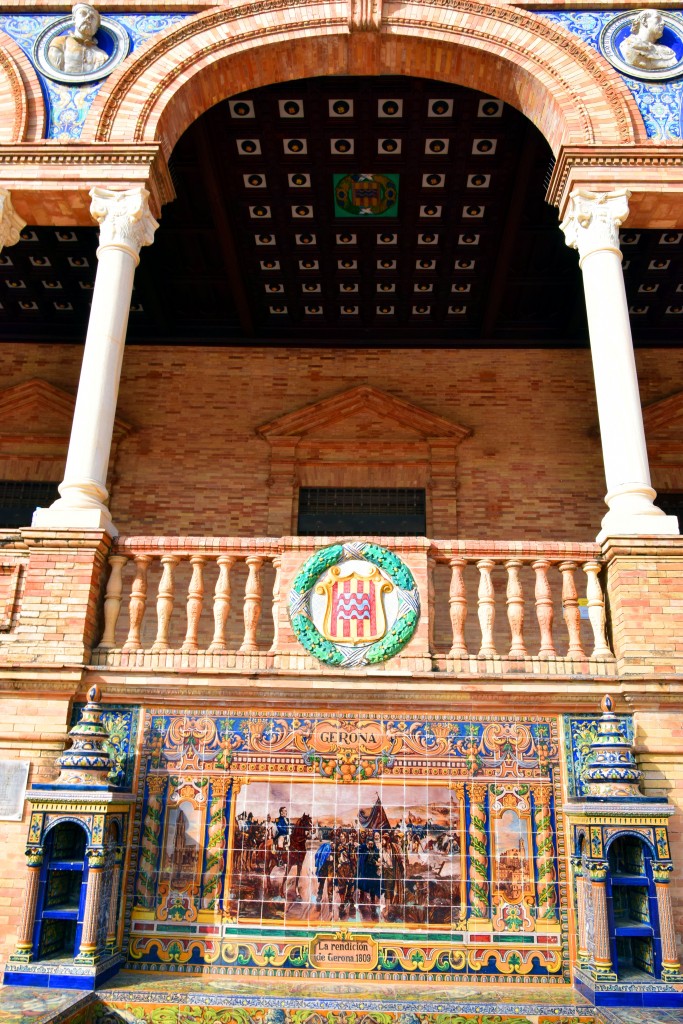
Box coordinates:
[600,8,683,82]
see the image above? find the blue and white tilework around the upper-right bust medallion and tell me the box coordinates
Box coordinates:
[543,10,683,142]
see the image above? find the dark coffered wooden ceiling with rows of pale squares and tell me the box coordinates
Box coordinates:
[0,77,683,347]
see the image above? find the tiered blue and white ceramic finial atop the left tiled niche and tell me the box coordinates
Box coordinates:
[50,686,115,790]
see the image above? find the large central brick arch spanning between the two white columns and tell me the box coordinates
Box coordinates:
[83,0,646,156]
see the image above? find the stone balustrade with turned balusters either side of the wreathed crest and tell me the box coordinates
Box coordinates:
[92,537,615,676]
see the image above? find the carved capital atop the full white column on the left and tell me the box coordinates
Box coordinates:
[90,186,159,265]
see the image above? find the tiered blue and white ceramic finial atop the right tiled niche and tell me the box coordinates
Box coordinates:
[583,695,642,800]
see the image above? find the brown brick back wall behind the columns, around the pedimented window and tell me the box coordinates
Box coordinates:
[0,344,671,541]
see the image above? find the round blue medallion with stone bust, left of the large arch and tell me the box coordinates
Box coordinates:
[34,3,130,85]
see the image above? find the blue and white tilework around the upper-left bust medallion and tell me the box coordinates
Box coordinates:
[0,13,188,141]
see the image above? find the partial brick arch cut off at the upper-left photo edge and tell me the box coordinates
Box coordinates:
[0,32,45,143]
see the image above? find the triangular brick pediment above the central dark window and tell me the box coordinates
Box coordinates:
[258,384,471,444]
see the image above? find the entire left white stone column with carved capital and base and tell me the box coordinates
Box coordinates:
[33,187,159,537]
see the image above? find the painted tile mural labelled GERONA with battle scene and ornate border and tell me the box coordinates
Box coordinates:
[129,711,566,981]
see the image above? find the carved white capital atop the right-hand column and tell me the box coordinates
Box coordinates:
[560,188,631,262]
